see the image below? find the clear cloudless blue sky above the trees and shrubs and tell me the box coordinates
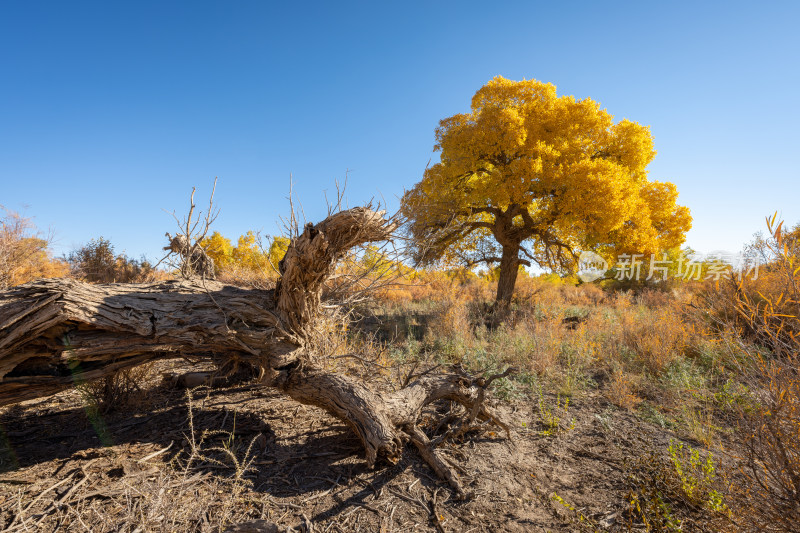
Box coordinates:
[0,0,800,264]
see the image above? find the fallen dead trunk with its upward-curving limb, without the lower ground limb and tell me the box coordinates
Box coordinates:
[0,207,396,405]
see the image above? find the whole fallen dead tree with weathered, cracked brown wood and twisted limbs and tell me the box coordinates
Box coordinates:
[0,208,505,496]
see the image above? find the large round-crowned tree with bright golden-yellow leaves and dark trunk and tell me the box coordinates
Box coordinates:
[402,76,691,306]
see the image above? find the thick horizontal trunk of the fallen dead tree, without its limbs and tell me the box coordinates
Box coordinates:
[0,279,302,405]
